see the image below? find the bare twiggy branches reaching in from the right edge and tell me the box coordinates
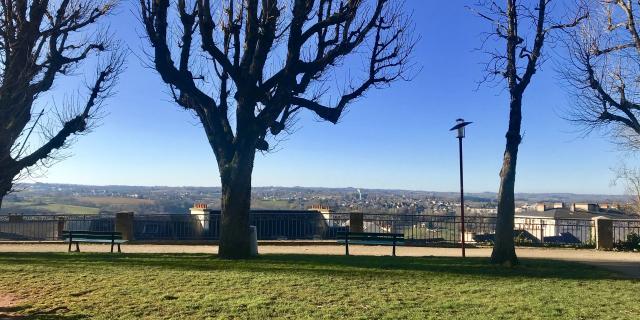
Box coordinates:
[564,0,640,150]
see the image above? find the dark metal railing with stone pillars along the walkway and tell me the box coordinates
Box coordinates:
[0,211,640,247]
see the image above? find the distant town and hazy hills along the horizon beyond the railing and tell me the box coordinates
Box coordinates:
[1,183,635,215]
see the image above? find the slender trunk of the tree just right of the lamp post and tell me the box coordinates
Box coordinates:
[491,93,522,265]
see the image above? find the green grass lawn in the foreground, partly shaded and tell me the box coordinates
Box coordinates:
[0,254,640,319]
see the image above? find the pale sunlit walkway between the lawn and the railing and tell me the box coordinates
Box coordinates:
[0,243,640,279]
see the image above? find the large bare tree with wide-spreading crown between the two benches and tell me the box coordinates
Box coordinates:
[140,0,415,258]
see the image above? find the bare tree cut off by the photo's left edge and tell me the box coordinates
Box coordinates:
[0,0,124,206]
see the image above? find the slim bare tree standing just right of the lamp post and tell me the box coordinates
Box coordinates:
[477,0,584,265]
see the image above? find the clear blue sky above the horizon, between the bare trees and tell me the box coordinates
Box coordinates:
[30,0,628,194]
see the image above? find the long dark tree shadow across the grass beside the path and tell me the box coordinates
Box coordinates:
[0,253,624,280]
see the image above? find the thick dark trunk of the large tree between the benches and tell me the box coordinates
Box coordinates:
[218,150,255,259]
